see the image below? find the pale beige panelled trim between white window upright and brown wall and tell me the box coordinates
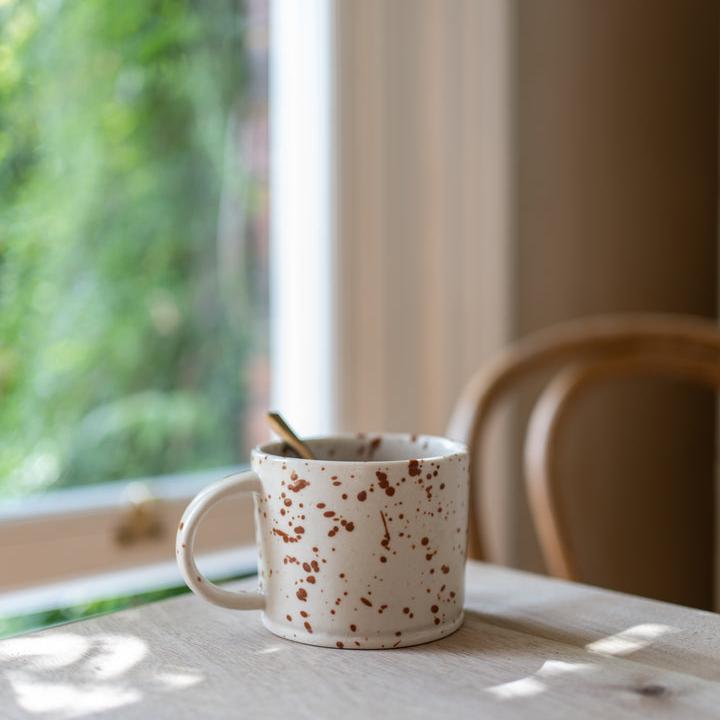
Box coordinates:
[334,0,512,433]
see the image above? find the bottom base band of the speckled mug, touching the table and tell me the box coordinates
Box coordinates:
[262,612,465,650]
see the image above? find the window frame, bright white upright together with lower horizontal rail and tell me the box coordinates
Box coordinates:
[0,0,335,597]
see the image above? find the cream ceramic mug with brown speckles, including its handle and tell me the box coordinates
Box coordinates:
[177,434,469,649]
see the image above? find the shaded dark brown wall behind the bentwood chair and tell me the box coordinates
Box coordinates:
[511,0,718,606]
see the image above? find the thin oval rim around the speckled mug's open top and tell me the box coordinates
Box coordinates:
[251,432,469,467]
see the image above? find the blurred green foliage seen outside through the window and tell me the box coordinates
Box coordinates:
[0,0,254,496]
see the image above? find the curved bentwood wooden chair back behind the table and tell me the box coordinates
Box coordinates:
[448,314,720,579]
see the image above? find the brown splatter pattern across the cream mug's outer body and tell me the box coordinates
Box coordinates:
[250,437,467,648]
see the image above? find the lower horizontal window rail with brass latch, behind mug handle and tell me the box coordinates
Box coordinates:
[0,468,255,593]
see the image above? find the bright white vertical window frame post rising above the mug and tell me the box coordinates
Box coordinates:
[270,0,338,435]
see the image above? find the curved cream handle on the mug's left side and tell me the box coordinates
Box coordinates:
[175,470,265,610]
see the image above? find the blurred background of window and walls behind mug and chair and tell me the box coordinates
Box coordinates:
[0,0,720,634]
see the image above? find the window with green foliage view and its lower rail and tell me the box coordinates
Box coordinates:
[0,0,268,588]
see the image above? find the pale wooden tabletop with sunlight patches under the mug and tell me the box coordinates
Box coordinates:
[0,563,720,720]
